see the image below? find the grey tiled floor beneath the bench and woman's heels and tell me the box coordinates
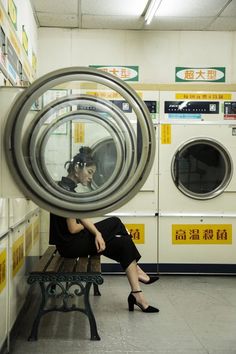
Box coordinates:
[10,275,236,354]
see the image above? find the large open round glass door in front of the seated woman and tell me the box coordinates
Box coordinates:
[5,67,155,218]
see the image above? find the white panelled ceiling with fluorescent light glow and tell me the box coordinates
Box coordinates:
[30,0,236,31]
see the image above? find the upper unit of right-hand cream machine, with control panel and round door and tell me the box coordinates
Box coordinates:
[159,92,236,215]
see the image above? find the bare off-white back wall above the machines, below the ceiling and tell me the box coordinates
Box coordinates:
[38,28,236,84]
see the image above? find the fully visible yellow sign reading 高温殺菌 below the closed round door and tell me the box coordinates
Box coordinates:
[172,224,232,245]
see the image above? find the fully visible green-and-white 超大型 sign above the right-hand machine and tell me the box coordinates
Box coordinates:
[175,67,225,82]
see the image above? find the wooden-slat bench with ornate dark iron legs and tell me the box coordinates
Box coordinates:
[27,246,103,341]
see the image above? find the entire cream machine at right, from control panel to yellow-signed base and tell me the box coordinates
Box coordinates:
[158,92,236,272]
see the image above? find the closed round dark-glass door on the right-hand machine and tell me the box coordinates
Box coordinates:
[171,138,233,200]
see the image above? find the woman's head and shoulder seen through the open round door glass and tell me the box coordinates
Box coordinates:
[58,146,96,193]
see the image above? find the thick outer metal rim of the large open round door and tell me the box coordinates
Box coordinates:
[5,67,155,216]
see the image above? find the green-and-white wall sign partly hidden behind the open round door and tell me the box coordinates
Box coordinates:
[89,65,139,81]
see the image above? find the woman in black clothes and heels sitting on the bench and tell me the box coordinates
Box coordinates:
[49,147,159,313]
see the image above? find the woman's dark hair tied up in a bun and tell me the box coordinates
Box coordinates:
[64,146,96,173]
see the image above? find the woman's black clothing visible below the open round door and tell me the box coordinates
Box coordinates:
[49,214,141,270]
